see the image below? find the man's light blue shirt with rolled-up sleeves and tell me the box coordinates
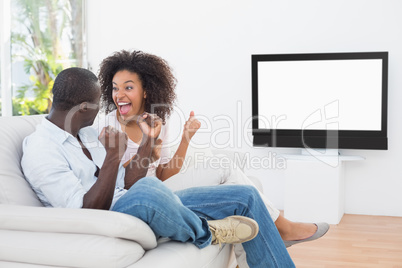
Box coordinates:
[21,118,126,208]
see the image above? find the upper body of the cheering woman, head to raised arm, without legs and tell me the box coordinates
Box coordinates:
[98,50,200,181]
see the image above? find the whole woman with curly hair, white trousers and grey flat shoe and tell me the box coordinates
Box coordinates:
[97,50,329,266]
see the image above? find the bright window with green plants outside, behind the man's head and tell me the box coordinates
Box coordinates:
[0,0,87,115]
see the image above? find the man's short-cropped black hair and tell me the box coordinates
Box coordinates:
[52,67,98,111]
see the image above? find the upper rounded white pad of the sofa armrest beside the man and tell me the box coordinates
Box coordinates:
[0,204,157,250]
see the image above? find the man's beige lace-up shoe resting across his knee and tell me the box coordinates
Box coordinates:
[208,216,259,246]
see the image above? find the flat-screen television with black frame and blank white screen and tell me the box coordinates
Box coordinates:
[251,52,388,150]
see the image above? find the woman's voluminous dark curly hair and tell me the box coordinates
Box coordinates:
[98,50,177,123]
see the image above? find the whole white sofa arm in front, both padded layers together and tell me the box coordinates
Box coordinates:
[0,204,157,268]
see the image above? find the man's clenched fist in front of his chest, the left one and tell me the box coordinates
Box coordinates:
[99,126,127,160]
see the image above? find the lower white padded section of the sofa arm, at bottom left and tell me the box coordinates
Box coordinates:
[0,230,144,268]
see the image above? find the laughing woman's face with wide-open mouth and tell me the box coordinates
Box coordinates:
[112,70,146,120]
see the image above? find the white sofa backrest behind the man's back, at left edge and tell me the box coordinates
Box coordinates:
[0,115,44,206]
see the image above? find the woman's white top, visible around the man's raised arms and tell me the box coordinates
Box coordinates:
[92,110,170,177]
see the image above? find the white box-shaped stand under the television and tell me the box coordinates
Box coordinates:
[282,149,364,224]
